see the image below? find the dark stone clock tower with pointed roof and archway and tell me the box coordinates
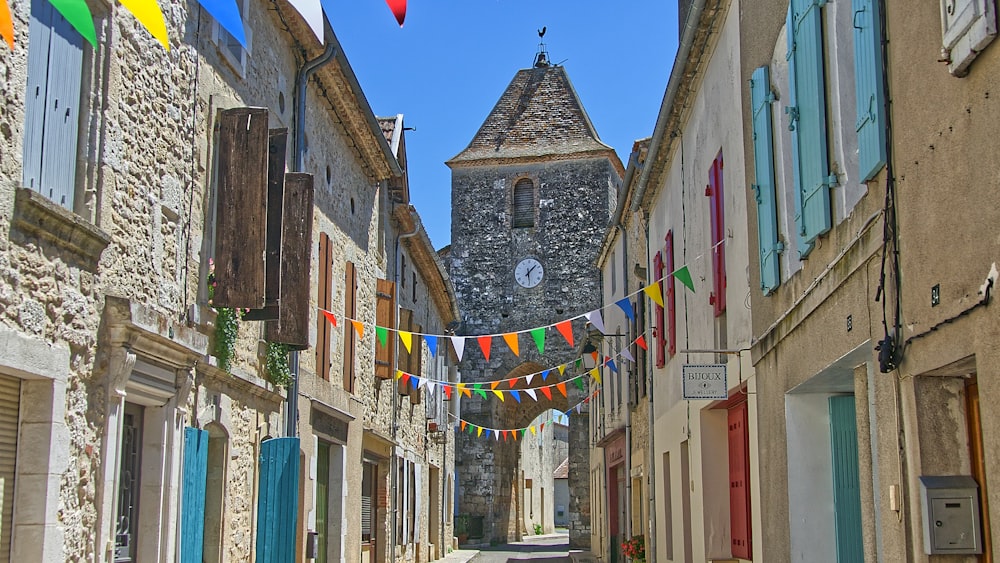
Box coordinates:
[447,51,623,547]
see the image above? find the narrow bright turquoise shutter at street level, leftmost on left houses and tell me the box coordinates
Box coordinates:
[181,428,208,563]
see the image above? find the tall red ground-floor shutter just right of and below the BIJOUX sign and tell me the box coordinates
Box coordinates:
[729,401,753,559]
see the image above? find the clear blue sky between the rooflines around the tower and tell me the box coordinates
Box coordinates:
[324,0,678,248]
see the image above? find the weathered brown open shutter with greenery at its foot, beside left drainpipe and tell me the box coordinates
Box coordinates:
[265,172,312,350]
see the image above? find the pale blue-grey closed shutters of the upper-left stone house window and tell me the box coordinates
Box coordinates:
[23,0,83,209]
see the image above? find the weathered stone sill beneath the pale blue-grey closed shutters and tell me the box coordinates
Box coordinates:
[14,188,111,269]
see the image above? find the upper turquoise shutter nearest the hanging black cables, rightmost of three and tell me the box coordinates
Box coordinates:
[852,0,886,181]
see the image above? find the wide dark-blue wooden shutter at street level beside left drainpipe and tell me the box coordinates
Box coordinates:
[257,438,299,563]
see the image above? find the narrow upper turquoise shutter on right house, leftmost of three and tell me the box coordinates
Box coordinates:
[750,65,785,295]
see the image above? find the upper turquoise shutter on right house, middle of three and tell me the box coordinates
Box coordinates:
[787,0,831,257]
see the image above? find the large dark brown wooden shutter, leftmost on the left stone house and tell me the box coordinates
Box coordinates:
[213,108,268,309]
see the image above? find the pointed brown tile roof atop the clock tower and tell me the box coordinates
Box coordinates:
[447,66,617,167]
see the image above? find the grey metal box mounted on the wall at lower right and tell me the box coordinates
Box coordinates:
[920,475,983,555]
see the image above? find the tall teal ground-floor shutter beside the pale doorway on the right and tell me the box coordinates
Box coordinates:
[829,395,865,563]
